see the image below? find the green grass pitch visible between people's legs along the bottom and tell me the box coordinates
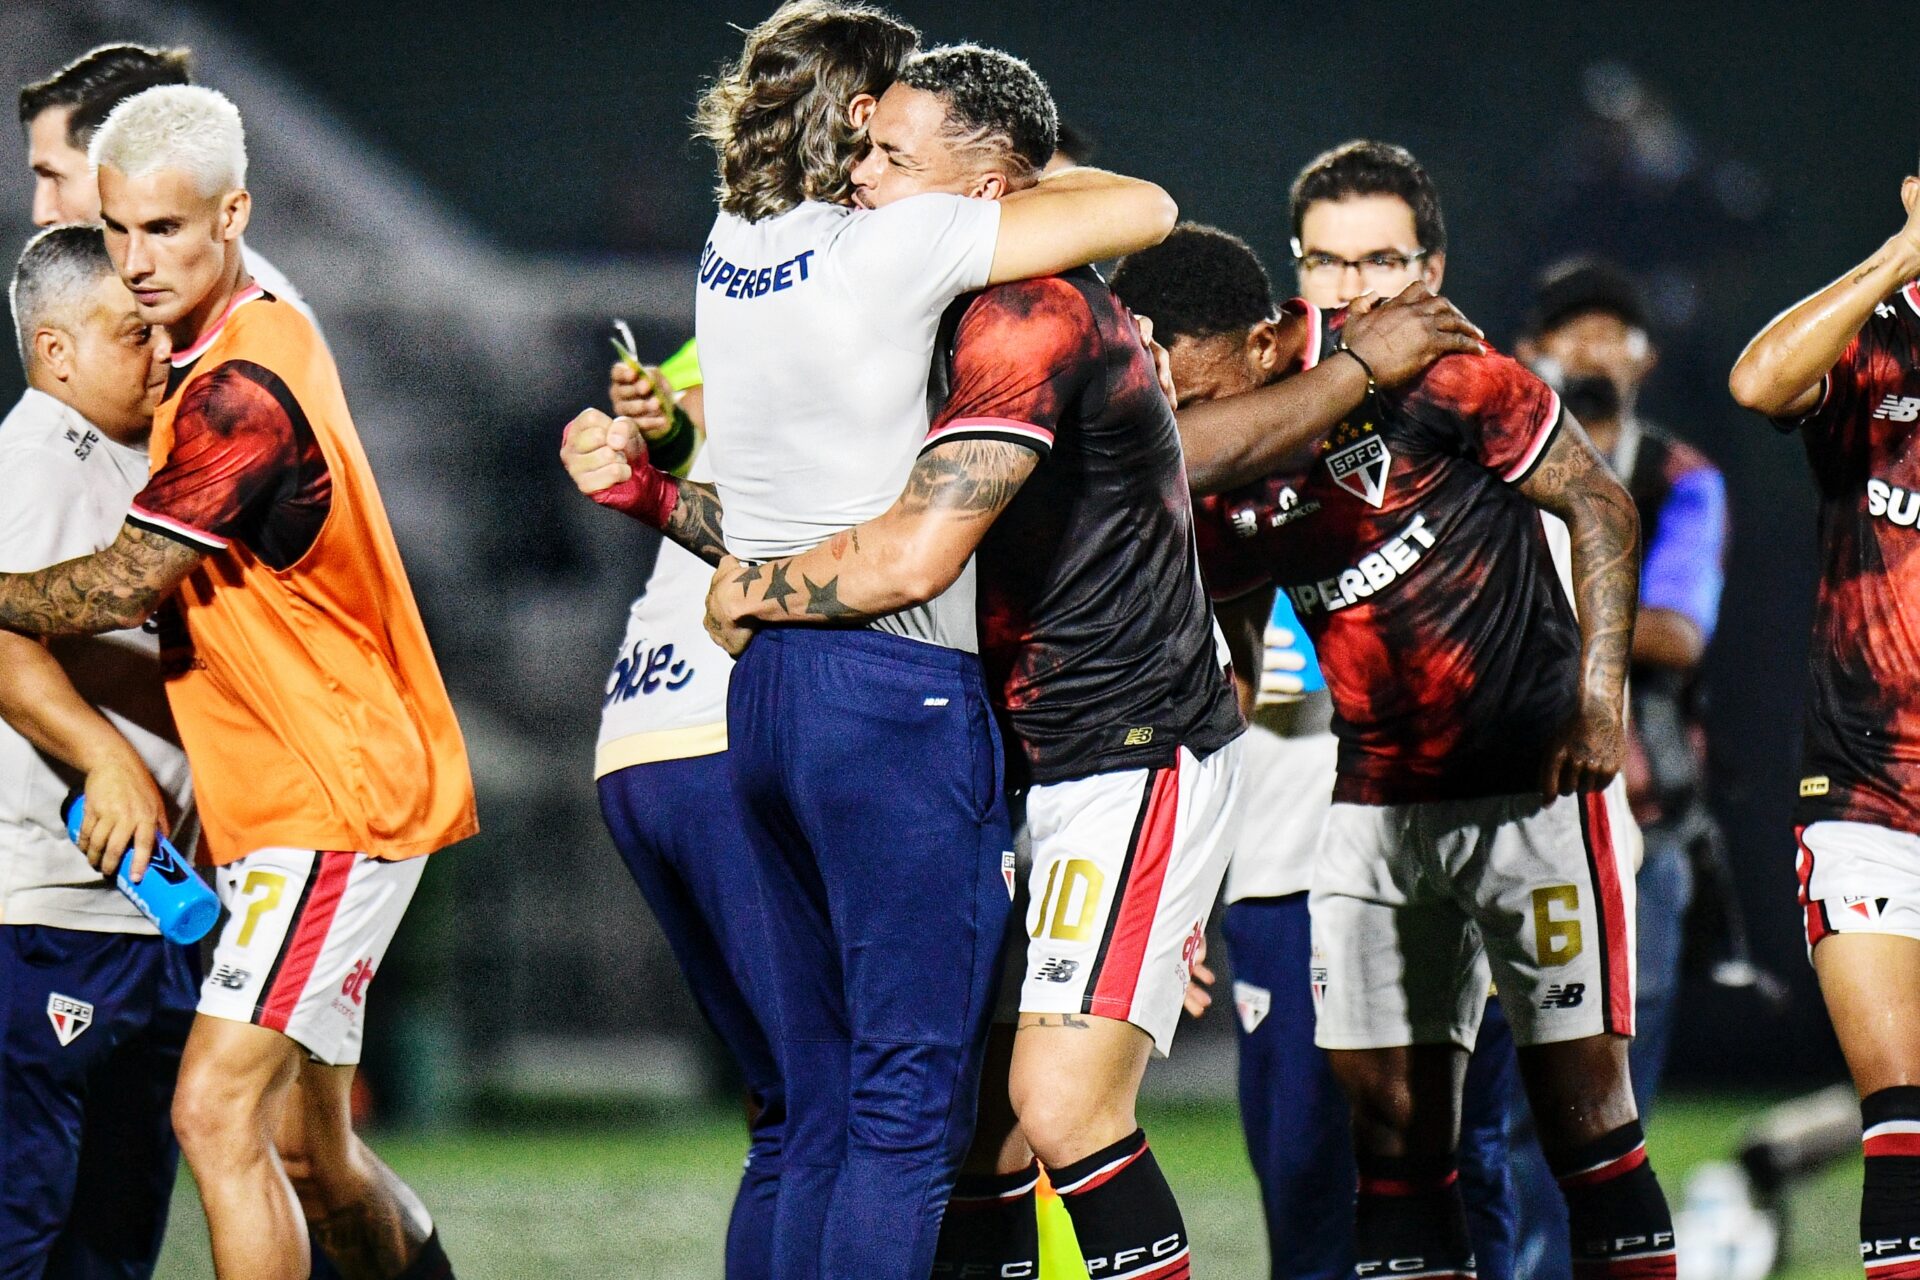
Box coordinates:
[157,1096,1860,1280]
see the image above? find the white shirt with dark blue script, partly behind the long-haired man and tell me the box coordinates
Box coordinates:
[593,451,733,777]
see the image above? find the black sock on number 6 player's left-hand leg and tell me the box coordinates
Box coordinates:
[1354,1153,1478,1280]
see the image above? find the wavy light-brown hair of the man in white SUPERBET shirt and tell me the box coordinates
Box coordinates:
[693,0,920,223]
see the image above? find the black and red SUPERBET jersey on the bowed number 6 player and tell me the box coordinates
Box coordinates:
[1198,301,1580,804]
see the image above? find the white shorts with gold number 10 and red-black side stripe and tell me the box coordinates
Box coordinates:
[1008,739,1240,1055]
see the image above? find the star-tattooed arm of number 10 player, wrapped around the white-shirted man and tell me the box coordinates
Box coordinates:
[707,439,1039,654]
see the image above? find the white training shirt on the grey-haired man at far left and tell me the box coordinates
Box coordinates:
[0,390,198,935]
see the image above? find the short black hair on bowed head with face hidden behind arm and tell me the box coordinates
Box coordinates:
[1114,223,1273,344]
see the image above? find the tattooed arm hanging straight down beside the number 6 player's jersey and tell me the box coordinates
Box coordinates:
[1521,415,1640,796]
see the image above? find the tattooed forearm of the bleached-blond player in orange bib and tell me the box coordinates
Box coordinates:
[0,524,202,635]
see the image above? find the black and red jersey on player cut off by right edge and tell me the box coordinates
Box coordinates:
[1784,284,1920,833]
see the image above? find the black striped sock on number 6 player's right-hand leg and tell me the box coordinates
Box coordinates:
[1548,1121,1674,1280]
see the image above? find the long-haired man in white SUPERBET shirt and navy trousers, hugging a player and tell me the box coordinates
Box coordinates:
[572,2,1175,1280]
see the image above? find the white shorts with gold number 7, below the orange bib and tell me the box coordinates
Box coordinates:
[200,848,426,1067]
